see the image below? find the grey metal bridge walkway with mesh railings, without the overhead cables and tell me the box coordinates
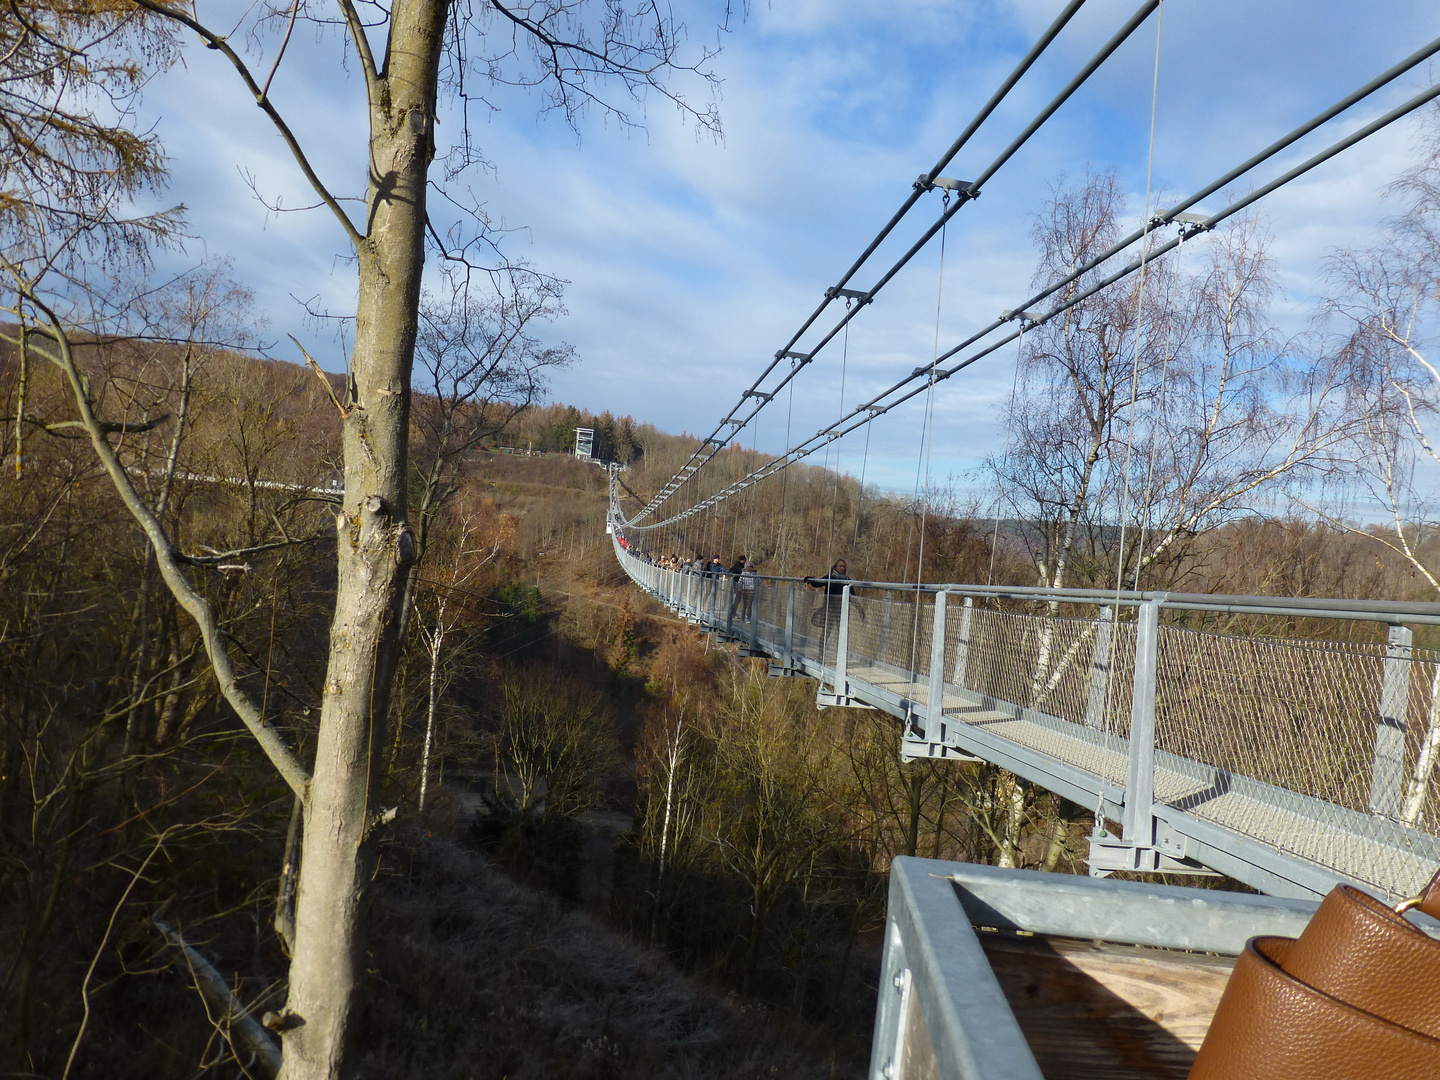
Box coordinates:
[615,539,1440,899]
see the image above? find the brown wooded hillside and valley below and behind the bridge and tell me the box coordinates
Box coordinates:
[0,319,1428,1076]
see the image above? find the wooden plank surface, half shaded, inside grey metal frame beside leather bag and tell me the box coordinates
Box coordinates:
[981,932,1234,1080]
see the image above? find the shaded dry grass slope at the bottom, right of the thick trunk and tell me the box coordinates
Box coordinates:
[359,818,864,1080]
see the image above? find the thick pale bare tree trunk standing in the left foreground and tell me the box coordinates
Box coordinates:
[281,0,446,1080]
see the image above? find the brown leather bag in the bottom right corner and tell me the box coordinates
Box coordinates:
[1189,873,1440,1080]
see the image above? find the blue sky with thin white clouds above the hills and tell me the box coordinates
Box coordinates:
[145,0,1440,491]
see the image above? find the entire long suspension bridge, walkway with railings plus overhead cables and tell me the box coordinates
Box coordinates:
[609,0,1440,915]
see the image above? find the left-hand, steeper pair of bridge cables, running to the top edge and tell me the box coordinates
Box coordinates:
[634,0,1161,521]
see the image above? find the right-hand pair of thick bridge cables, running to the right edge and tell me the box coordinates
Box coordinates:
[639,63,1440,538]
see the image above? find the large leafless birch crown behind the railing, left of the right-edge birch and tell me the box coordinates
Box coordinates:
[989,176,1351,588]
